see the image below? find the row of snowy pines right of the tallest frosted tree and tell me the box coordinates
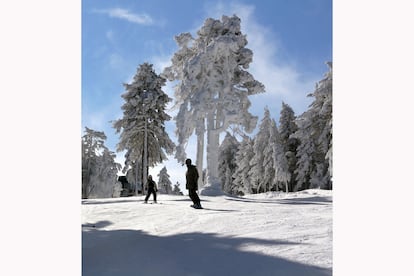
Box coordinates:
[219,62,332,195]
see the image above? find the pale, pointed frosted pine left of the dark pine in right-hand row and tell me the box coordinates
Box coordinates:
[250,107,273,193]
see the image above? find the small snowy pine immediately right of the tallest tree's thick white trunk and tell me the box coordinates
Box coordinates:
[218,132,239,194]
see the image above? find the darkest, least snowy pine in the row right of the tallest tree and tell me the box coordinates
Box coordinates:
[279,102,299,191]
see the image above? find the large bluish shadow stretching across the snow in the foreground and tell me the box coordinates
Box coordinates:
[82,223,332,276]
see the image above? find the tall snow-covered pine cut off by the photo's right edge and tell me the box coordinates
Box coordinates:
[292,62,332,190]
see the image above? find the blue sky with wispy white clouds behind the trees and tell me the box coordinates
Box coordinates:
[81,0,332,188]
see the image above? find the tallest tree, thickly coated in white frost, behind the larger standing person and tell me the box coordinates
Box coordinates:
[163,15,264,195]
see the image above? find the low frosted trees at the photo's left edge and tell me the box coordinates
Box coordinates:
[82,127,121,198]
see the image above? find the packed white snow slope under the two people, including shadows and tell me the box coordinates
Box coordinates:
[82,190,332,276]
